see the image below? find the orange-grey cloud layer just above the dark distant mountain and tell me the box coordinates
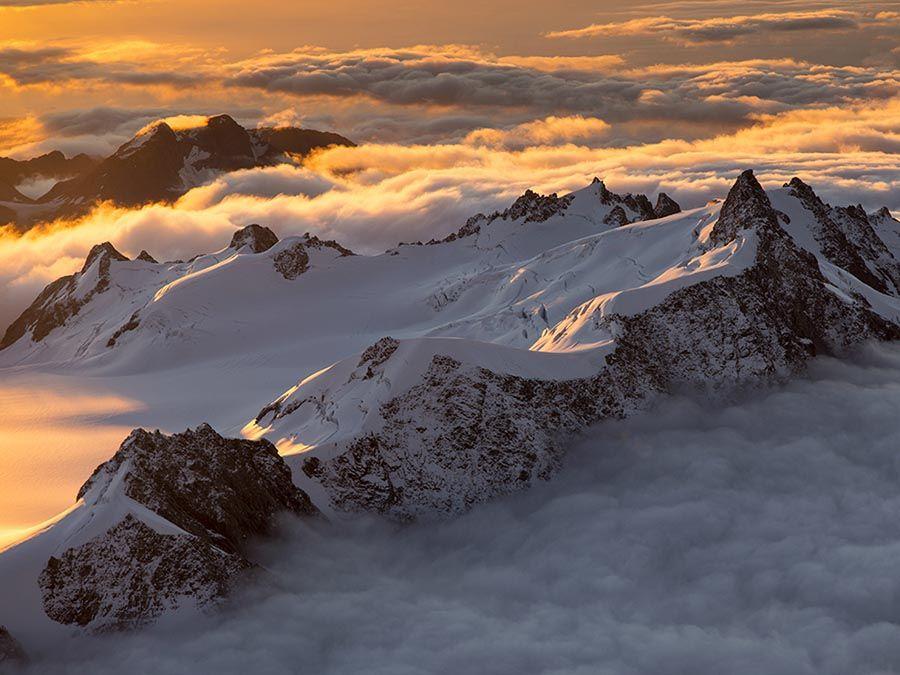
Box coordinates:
[0,41,900,155]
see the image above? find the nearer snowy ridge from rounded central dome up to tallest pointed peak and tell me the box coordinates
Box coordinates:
[245,171,900,520]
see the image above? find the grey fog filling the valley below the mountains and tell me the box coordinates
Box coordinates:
[17,346,900,675]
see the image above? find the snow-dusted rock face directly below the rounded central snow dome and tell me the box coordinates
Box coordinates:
[303,356,624,520]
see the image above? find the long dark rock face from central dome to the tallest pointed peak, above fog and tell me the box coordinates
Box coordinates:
[296,172,900,520]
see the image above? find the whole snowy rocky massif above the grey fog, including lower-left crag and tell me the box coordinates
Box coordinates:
[0,169,900,646]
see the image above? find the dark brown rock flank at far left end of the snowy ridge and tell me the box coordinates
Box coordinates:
[0,241,128,349]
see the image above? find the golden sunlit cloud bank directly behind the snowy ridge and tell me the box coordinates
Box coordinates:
[0,99,900,336]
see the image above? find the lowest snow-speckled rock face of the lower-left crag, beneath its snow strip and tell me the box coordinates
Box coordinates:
[38,515,251,632]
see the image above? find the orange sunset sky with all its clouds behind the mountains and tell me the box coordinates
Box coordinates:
[0,0,900,325]
